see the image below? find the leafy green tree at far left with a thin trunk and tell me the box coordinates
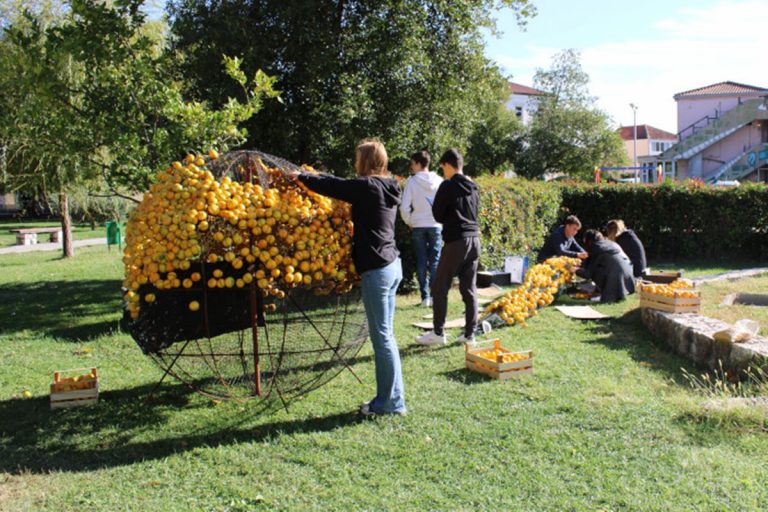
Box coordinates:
[0,0,277,256]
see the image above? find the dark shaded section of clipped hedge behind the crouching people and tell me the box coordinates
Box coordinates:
[561,184,768,260]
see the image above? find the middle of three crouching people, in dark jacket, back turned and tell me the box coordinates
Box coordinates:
[576,229,635,302]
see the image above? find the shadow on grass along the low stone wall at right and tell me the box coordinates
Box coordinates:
[586,309,694,387]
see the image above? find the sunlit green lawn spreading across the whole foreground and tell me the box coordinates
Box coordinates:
[0,248,768,511]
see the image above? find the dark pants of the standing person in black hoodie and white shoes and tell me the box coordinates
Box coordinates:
[432,237,480,336]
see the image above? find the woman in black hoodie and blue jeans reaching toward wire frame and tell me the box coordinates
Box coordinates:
[294,140,406,416]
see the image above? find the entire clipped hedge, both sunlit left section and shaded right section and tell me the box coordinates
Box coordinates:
[397,177,768,292]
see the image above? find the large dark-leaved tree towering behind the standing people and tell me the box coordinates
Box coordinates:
[170,0,535,173]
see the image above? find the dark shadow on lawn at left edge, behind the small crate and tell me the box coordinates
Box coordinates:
[0,280,121,341]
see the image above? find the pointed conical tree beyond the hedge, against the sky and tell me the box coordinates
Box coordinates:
[516,50,626,178]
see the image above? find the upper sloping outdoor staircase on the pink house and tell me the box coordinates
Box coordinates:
[657,99,768,162]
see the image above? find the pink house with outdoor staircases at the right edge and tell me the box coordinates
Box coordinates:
[642,82,768,183]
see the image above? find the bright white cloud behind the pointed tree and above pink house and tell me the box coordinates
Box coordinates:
[496,1,768,132]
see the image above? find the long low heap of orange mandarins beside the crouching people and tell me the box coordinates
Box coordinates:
[485,256,581,325]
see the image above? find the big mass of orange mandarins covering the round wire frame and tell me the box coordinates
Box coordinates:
[123,150,357,320]
